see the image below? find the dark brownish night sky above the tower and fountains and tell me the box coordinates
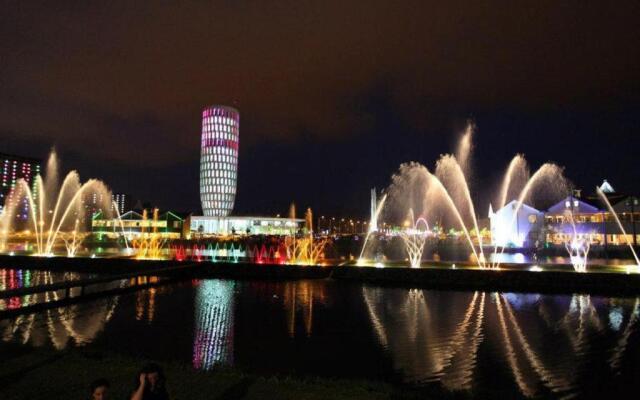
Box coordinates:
[0,0,640,216]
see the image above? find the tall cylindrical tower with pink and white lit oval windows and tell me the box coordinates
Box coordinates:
[200,106,240,217]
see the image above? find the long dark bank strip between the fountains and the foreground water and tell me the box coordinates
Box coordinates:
[0,255,640,296]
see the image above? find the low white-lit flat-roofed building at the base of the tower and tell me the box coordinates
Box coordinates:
[187,216,305,238]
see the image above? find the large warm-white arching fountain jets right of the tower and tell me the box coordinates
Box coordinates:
[358,124,567,269]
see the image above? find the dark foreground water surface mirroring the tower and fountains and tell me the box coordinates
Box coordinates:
[0,279,640,398]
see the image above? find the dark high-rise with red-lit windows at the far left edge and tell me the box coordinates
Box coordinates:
[0,153,40,221]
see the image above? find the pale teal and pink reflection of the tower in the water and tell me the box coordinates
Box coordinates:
[193,280,234,370]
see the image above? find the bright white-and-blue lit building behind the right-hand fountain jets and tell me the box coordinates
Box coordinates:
[489,200,544,248]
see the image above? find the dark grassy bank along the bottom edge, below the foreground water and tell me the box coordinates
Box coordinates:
[0,346,457,400]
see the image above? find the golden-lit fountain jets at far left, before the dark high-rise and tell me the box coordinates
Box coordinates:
[0,151,111,256]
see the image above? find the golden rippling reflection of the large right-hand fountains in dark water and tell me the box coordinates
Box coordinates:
[363,287,640,397]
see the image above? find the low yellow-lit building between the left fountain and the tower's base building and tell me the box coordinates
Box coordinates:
[91,210,185,240]
